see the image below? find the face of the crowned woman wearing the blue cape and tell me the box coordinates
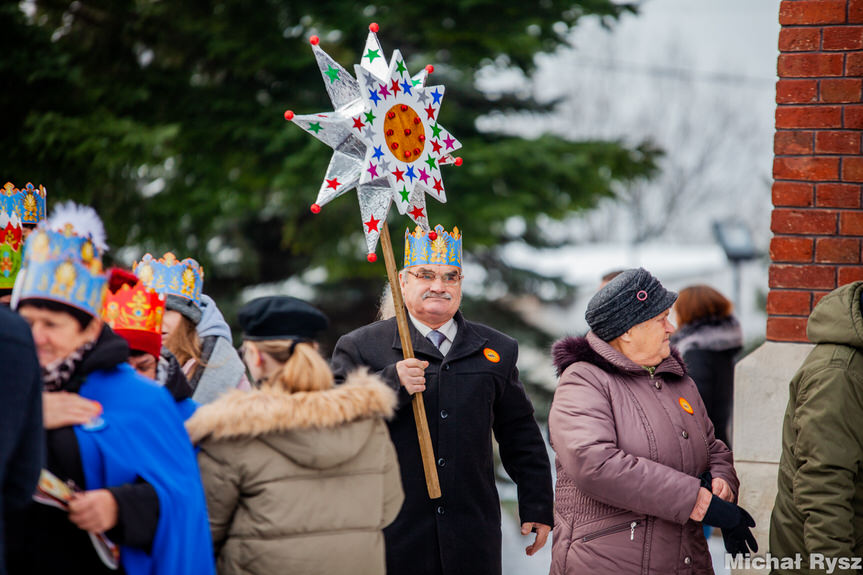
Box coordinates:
[19,305,102,367]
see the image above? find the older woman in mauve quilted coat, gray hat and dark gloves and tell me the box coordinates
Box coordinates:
[549,269,757,575]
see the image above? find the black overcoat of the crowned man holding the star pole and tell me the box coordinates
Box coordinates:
[332,312,554,575]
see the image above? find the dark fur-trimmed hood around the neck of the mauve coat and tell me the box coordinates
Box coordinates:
[551,332,686,377]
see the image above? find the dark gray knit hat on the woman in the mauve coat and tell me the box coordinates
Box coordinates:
[584,268,677,341]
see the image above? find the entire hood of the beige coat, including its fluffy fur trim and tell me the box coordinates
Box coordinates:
[186,369,396,468]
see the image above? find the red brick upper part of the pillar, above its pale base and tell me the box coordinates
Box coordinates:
[767,0,863,341]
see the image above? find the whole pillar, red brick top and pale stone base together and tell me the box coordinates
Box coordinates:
[733,0,863,574]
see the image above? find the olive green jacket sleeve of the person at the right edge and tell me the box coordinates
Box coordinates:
[792,366,863,557]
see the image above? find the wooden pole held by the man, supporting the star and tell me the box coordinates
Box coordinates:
[381,222,441,499]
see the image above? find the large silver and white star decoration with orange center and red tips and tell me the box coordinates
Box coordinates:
[285,24,461,261]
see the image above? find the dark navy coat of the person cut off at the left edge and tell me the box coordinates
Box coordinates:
[0,305,44,575]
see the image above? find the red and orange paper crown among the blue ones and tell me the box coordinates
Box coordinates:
[102,281,165,355]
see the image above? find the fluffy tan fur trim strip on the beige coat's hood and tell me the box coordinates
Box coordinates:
[186,368,396,443]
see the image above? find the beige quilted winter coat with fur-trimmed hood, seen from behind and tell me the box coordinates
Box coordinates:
[186,371,404,575]
